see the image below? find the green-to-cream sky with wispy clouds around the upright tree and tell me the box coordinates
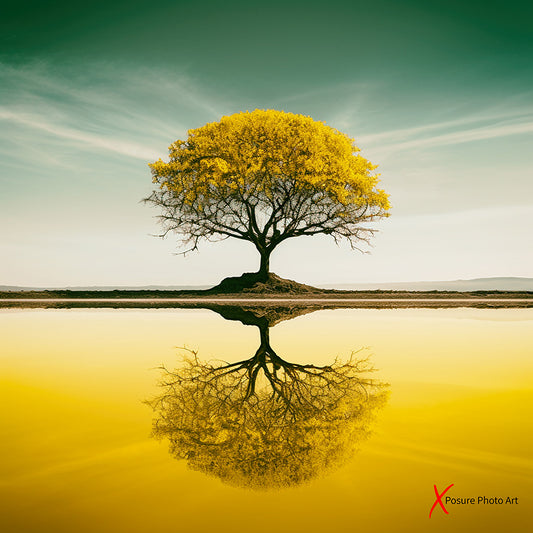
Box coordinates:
[0,0,533,287]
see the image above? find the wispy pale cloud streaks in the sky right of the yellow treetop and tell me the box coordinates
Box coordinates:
[308,79,533,154]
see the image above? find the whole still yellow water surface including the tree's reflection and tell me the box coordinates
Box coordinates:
[0,308,533,533]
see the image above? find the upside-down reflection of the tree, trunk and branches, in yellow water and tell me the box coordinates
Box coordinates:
[149,308,387,489]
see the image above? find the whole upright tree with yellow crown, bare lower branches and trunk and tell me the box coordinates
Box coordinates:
[146,110,389,281]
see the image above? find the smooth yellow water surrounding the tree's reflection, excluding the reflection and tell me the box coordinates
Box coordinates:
[0,309,533,533]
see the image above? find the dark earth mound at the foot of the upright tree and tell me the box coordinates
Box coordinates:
[205,272,327,294]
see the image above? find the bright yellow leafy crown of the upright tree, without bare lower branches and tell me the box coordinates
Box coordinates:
[150,110,390,211]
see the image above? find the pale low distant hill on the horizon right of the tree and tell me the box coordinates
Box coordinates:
[320,278,533,291]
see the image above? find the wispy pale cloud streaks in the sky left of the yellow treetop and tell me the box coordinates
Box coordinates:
[0,64,227,160]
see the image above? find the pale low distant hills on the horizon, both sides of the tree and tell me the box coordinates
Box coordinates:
[0,277,533,292]
